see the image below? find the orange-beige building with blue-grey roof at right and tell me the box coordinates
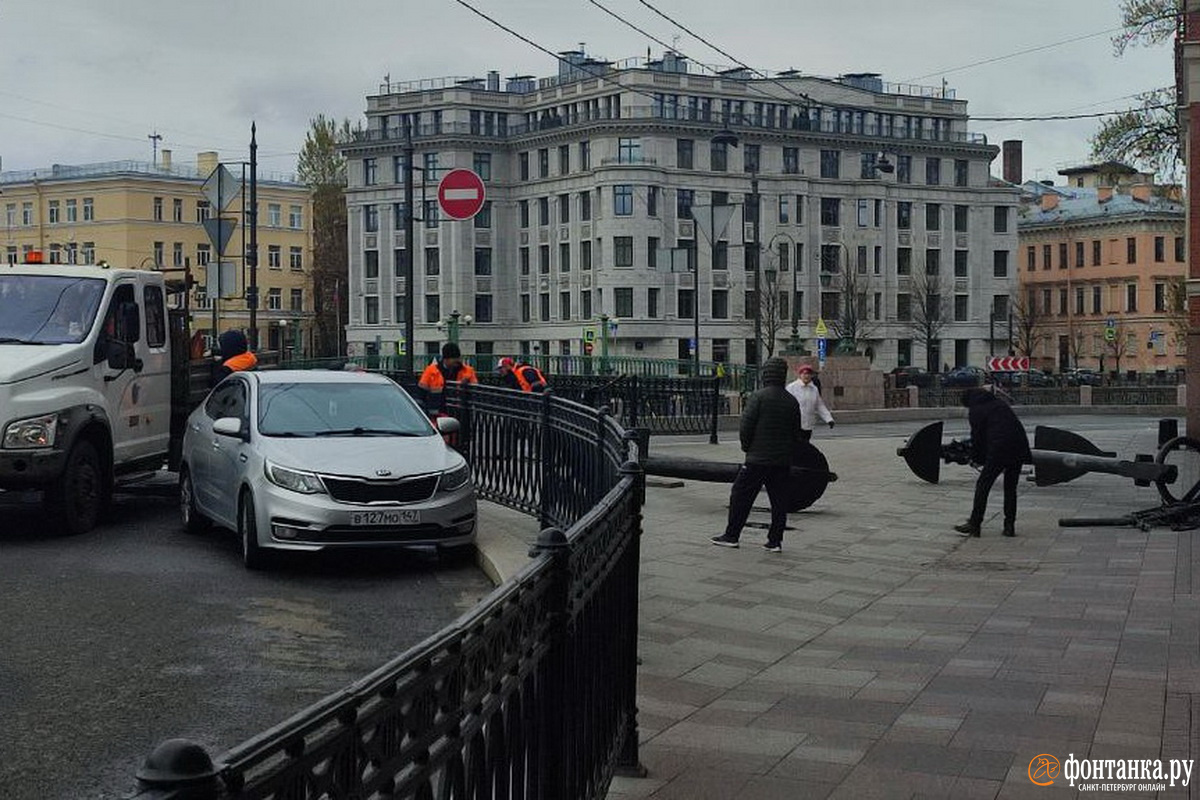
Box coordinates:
[1014,163,1187,373]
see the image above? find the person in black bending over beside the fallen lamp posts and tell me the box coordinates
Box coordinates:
[954,389,1033,536]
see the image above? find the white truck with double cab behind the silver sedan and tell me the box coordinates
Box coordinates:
[0,255,194,534]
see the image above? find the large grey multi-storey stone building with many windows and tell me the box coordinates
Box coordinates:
[344,52,1019,369]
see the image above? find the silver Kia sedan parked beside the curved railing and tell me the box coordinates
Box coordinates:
[179,369,476,569]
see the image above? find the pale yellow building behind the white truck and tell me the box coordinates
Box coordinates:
[0,150,313,355]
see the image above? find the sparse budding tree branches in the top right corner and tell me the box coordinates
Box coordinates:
[1091,0,1182,181]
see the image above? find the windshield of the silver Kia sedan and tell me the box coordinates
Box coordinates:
[258,381,437,437]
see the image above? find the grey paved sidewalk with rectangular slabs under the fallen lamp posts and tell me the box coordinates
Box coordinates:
[477,419,1200,800]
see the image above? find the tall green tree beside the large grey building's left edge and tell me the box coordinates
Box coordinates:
[298,114,354,356]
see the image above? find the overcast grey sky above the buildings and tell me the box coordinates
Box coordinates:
[0,0,1174,181]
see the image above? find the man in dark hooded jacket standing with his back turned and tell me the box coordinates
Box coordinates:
[712,359,800,553]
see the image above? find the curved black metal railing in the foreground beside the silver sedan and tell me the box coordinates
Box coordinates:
[137,381,644,800]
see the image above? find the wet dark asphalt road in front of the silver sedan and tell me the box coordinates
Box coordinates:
[0,495,491,800]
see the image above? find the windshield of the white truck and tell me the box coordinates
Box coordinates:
[0,275,104,344]
